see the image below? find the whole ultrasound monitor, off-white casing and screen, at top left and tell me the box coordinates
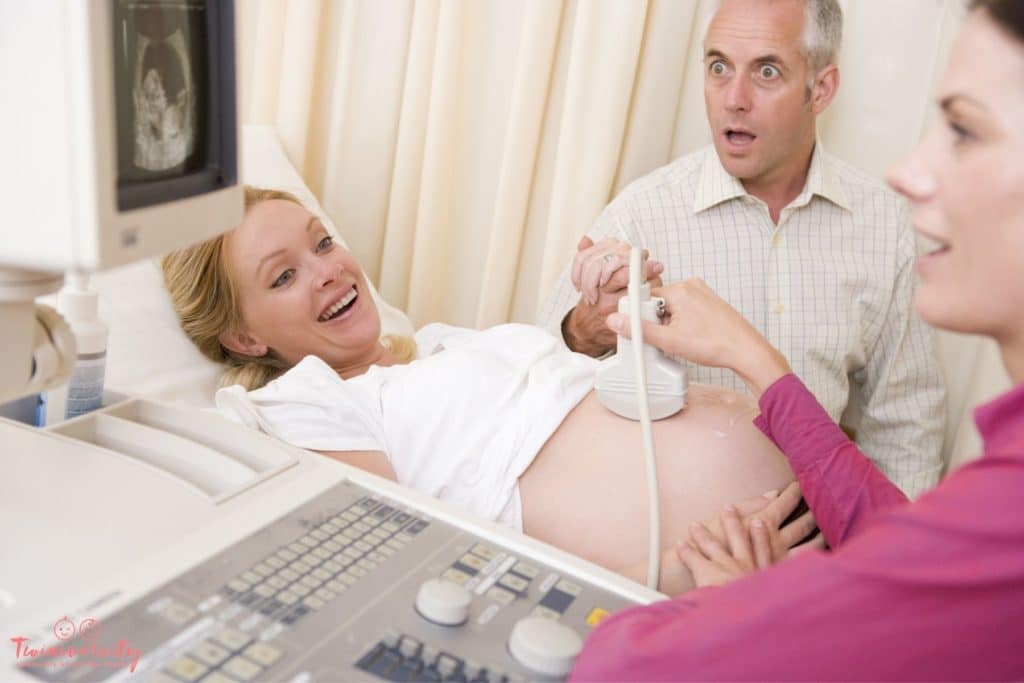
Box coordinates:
[0,0,243,271]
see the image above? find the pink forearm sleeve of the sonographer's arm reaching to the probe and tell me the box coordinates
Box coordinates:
[754,375,906,548]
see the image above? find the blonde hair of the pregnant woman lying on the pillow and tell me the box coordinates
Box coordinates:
[160,185,416,391]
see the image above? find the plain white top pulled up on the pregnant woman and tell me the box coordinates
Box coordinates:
[216,324,597,530]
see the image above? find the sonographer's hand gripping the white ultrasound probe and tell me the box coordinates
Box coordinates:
[607,278,793,396]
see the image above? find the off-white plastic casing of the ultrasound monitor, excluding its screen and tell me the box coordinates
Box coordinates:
[0,0,242,271]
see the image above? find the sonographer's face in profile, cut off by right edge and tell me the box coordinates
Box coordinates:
[888,10,1024,342]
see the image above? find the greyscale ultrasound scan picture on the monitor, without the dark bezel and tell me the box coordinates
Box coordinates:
[115,0,209,184]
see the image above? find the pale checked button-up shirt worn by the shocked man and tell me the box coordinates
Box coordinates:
[539,144,945,496]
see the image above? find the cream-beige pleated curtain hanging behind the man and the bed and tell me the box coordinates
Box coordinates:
[238,0,1002,466]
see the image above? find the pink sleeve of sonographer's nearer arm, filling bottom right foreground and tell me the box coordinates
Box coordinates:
[572,456,1024,681]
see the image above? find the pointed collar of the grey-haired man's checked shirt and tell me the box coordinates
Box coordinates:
[693,140,852,213]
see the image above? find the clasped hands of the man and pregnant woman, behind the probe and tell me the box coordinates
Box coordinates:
[562,237,665,356]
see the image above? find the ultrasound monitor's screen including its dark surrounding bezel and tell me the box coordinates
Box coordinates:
[114,0,234,210]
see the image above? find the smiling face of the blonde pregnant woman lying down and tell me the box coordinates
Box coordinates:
[221,200,381,376]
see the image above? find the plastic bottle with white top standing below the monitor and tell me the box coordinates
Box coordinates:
[44,271,108,424]
